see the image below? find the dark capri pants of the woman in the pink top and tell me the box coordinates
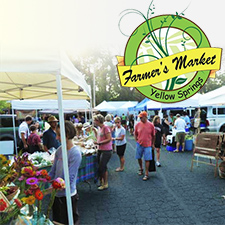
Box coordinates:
[97,150,112,178]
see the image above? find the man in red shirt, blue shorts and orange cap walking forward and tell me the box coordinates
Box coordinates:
[134,111,155,181]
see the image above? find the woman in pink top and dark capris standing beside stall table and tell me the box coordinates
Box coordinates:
[94,114,112,191]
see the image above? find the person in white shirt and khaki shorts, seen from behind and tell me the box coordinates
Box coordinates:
[173,114,186,152]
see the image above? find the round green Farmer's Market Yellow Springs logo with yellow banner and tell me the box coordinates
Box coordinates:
[117,6,222,103]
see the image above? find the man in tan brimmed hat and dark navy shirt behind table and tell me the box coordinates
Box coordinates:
[43,116,61,152]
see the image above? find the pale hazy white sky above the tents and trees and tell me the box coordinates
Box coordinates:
[0,0,225,55]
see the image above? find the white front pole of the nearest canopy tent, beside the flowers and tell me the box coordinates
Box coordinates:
[56,73,74,225]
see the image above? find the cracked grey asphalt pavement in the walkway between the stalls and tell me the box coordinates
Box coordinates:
[77,136,225,225]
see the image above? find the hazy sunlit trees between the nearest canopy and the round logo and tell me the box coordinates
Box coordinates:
[73,49,144,105]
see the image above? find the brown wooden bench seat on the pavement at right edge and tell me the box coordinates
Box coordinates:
[191,133,222,177]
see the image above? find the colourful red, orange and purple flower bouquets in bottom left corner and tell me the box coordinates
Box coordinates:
[0,154,65,225]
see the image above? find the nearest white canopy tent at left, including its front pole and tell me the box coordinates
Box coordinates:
[0,45,91,225]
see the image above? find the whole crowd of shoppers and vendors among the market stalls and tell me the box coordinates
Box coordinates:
[15,108,196,224]
